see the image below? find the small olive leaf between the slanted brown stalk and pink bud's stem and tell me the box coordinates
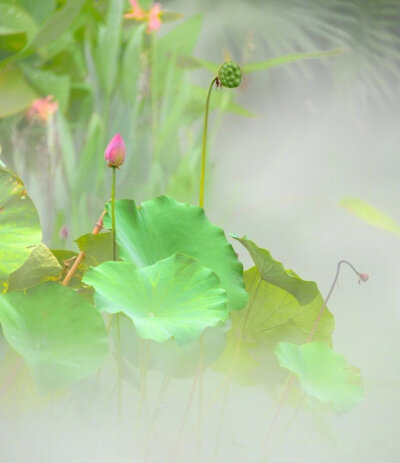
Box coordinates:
[76,232,113,267]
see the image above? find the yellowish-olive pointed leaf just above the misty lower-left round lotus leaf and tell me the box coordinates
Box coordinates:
[7,243,61,292]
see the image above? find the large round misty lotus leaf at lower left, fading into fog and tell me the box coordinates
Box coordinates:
[0,282,108,392]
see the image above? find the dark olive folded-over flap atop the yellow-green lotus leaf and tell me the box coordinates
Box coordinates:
[233,236,319,304]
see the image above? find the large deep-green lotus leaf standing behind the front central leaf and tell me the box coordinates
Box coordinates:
[105,196,248,311]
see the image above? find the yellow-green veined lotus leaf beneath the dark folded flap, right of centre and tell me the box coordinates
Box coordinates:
[214,267,334,385]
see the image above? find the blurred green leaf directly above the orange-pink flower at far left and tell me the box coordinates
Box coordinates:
[20,63,70,112]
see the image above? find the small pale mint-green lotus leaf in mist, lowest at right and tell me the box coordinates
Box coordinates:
[275,341,363,412]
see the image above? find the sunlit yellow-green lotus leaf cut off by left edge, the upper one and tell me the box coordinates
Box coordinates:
[0,167,42,287]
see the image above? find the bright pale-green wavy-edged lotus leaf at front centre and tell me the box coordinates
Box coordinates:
[82,254,228,345]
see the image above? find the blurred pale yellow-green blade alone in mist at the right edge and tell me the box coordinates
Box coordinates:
[340,198,400,235]
